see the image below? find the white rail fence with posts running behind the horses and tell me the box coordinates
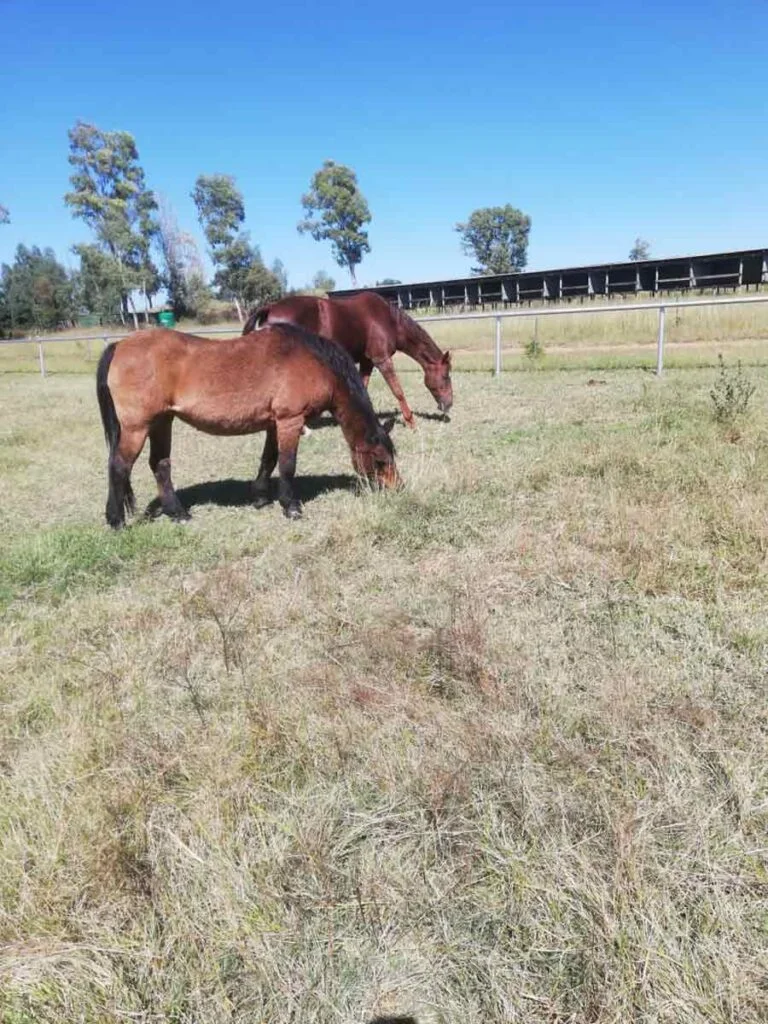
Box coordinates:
[0,295,768,377]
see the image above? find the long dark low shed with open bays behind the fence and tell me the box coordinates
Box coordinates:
[330,247,768,309]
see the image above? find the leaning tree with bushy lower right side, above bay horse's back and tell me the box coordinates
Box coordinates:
[191,174,285,323]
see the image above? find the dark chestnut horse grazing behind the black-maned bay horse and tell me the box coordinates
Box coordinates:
[243,292,454,427]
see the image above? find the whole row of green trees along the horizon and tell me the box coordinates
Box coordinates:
[0,122,649,334]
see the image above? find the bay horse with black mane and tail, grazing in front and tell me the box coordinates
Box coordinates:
[96,324,400,527]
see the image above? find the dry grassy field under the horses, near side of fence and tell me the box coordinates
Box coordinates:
[0,369,768,1024]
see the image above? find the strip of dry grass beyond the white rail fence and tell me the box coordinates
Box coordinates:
[0,296,768,374]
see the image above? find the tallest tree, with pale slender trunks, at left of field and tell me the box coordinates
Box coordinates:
[65,121,160,326]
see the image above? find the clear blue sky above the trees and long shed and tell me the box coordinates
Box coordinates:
[0,0,768,286]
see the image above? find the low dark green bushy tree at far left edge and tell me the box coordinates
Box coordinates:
[2,246,77,330]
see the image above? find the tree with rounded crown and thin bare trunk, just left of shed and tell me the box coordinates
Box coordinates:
[298,160,371,286]
